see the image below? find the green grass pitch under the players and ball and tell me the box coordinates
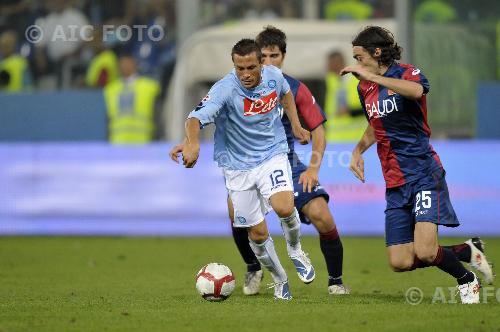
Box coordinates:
[0,236,500,332]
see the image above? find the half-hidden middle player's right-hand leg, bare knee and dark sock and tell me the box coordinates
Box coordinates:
[295,196,350,294]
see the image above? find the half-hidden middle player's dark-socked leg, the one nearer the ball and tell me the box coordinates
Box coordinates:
[227,196,264,295]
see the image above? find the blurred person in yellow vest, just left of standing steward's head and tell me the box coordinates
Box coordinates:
[85,29,118,88]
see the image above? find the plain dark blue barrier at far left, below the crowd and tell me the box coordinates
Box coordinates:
[0,91,107,142]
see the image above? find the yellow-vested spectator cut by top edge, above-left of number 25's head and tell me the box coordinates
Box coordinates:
[324,0,373,21]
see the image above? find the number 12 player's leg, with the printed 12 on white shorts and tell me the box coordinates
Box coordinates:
[256,154,316,283]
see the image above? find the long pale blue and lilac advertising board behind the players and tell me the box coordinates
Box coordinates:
[0,141,500,236]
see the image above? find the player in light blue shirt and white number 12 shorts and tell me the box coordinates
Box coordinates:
[170,39,315,300]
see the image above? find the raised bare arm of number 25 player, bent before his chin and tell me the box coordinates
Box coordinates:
[340,65,424,100]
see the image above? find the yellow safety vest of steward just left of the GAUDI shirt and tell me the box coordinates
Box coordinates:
[325,73,367,142]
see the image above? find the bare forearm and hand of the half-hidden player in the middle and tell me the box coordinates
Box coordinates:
[299,125,326,193]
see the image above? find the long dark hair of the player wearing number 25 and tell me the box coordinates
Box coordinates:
[352,26,403,66]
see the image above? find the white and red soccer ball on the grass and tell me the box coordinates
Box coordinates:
[196,263,236,301]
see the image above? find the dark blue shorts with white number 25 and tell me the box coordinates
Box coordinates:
[385,169,460,246]
